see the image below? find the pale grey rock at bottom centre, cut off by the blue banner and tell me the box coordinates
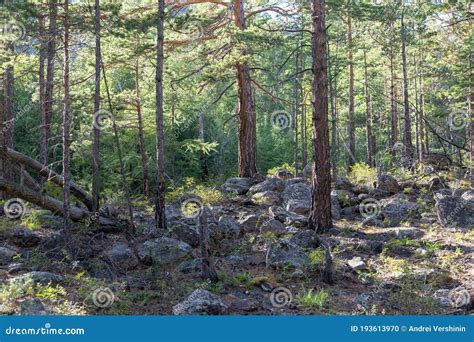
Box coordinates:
[173,289,228,316]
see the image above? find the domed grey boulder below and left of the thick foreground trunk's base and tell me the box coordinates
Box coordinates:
[266,240,309,269]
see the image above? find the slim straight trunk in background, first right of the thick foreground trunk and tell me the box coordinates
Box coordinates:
[347,13,356,171]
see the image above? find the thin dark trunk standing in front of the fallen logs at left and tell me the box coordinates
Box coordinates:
[62,0,71,236]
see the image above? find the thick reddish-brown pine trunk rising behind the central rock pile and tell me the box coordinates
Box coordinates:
[234,0,257,177]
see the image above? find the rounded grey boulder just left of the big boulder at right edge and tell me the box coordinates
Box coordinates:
[380,196,421,226]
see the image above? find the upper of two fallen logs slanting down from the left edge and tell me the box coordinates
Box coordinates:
[0,148,92,211]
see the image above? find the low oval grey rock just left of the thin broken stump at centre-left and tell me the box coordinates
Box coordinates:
[138,237,193,265]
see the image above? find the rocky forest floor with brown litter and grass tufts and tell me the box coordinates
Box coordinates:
[0,171,474,315]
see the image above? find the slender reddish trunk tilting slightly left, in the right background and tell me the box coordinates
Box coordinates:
[401,12,413,167]
